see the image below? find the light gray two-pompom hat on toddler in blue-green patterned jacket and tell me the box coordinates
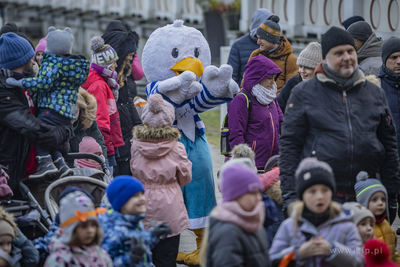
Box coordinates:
[44,26,74,55]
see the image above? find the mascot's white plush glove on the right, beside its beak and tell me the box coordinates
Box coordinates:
[201,64,240,98]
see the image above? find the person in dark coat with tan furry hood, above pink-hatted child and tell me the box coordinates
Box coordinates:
[68,89,107,167]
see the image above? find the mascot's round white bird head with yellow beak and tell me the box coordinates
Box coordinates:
[142,20,211,82]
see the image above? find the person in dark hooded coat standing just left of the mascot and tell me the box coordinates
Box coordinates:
[102,20,141,176]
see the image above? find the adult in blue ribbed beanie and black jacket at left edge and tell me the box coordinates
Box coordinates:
[0,33,73,196]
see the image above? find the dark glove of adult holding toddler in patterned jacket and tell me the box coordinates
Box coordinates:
[36,124,74,155]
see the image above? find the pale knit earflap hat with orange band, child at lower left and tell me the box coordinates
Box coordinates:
[60,191,98,244]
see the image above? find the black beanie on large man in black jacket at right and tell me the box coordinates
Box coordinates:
[321,26,356,58]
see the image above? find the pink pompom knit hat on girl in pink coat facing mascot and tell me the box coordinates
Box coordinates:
[142,94,175,127]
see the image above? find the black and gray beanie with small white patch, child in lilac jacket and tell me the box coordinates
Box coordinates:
[295,158,336,200]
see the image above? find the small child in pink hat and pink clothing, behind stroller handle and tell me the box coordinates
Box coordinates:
[74,136,105,171]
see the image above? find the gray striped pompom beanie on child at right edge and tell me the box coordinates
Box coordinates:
[354,174,387,211]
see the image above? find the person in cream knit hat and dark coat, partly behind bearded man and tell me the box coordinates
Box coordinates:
[277,42,322,113]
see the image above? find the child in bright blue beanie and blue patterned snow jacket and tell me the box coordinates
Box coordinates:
[99,175,171,267]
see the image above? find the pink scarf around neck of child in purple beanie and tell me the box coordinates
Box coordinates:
[211,201,265,233]
